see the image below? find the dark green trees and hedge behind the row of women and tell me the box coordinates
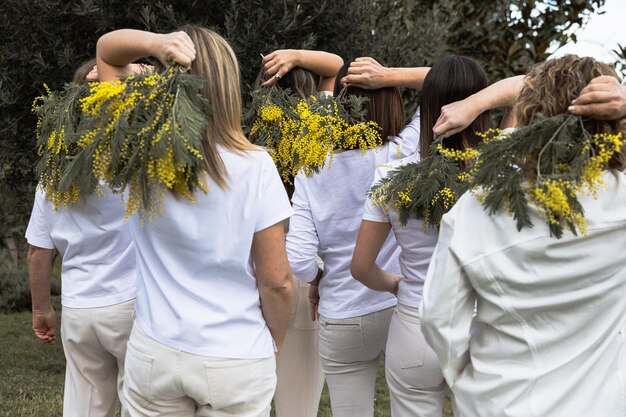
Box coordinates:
[0,0,604,255]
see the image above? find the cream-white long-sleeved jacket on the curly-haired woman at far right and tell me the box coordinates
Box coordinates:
[422,172,626,417]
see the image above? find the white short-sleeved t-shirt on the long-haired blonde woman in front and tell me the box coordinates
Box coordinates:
[130,148,292,359]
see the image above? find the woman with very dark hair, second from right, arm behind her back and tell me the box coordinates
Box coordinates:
[351,55,490,417]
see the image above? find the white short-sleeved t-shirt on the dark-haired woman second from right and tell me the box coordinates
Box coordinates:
[363,154,439,308]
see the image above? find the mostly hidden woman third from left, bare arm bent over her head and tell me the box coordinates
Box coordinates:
[255,49,343,417]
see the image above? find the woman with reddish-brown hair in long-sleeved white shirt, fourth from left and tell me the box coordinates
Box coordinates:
[287,58,421,417]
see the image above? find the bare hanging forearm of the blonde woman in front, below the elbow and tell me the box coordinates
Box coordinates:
[259,279,293,348]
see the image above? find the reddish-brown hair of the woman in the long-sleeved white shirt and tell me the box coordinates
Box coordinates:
[334,62,405,142]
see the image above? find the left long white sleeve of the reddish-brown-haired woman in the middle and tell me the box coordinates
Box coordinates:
[287,174,319,282]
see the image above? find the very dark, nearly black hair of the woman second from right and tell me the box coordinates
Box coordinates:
[420,55,490,161]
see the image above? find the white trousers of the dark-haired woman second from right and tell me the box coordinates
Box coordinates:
[385,304,446,417]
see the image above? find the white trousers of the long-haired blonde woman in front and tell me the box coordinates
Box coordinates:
[124,324,276,417]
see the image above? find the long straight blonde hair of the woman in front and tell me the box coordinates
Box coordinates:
[180,25,259,188]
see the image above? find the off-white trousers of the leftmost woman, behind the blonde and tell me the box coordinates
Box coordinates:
[61,300,135,417]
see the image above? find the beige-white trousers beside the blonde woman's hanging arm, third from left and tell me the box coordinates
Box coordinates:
[274,277,324,417]
